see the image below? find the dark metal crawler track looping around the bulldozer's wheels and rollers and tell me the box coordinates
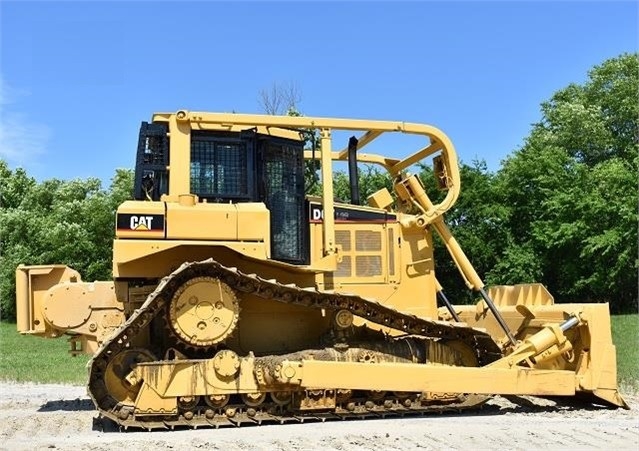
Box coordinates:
[88,259,501,429]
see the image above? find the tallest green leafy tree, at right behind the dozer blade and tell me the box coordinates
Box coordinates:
[490,54,639,312]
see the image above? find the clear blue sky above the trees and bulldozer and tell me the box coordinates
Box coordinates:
[0,0,639,187]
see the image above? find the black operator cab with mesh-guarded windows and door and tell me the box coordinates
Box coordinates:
[134,122,310,264]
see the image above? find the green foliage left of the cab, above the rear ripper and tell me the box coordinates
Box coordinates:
[0,166,133,319]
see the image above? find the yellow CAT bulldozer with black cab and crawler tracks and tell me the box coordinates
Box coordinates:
[16,110,627,429]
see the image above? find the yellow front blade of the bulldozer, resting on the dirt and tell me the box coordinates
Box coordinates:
[455,290,628,408]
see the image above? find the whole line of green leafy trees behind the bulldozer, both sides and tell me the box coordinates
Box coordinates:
[0,54,639,320]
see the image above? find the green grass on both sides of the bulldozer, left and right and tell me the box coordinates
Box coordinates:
[0,314,639,393]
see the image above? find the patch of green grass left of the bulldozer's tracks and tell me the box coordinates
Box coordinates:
[0,323,90,384]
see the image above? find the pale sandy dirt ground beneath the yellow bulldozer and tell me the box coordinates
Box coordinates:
[0,383,639,451]
